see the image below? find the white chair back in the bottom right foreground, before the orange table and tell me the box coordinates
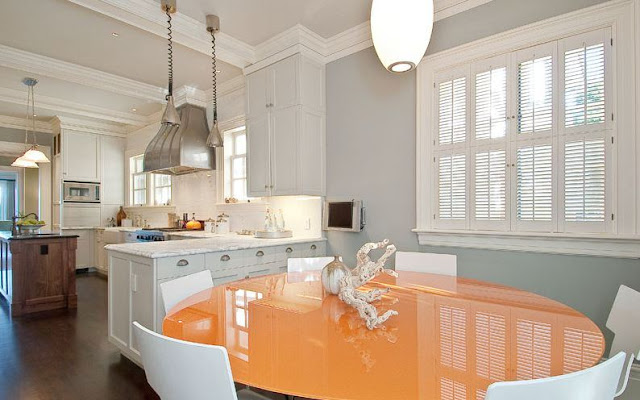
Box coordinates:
[485,352,626,400]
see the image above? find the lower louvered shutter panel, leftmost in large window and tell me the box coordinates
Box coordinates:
[438,154,467,220]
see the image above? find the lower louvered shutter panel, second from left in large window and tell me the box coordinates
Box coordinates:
[475,150,507,221]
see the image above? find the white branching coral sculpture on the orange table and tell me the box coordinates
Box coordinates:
[338,239,398,329]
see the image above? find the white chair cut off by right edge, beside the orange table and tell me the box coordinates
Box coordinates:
[606,285,640,397]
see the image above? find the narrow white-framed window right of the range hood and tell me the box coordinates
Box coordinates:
[224,126,247,200]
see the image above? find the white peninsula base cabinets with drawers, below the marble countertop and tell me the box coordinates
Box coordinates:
[105,241,325,363]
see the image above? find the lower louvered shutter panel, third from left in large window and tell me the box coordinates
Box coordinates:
[516,145,553,221]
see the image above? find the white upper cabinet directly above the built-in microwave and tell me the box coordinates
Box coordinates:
[62,130,100,182]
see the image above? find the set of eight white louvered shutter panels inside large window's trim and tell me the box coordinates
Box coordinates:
[430,29,614,233]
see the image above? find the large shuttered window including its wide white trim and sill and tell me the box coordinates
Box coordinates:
[415,1,640,257]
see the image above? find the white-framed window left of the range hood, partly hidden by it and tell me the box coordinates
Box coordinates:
[129,155,171,206]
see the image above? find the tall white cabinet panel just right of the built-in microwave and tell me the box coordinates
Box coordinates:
[100,136,125,206]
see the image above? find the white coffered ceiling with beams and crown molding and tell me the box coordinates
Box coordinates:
[0,0,490,134]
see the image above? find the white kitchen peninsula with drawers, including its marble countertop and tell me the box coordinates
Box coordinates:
[105,232,326,364]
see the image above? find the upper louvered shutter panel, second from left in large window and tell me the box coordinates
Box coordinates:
[476,67,507,140]
